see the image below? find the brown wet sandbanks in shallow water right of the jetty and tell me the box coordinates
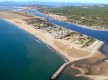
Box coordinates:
[70,51,108,80]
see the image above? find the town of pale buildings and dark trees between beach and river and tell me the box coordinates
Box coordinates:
[24,17,95,48]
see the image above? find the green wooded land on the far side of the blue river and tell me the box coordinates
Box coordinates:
[39,6,108,29]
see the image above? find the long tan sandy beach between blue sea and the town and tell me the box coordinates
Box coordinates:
[0,12,103,61]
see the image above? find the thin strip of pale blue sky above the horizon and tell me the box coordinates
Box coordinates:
[0,0,108,4]
